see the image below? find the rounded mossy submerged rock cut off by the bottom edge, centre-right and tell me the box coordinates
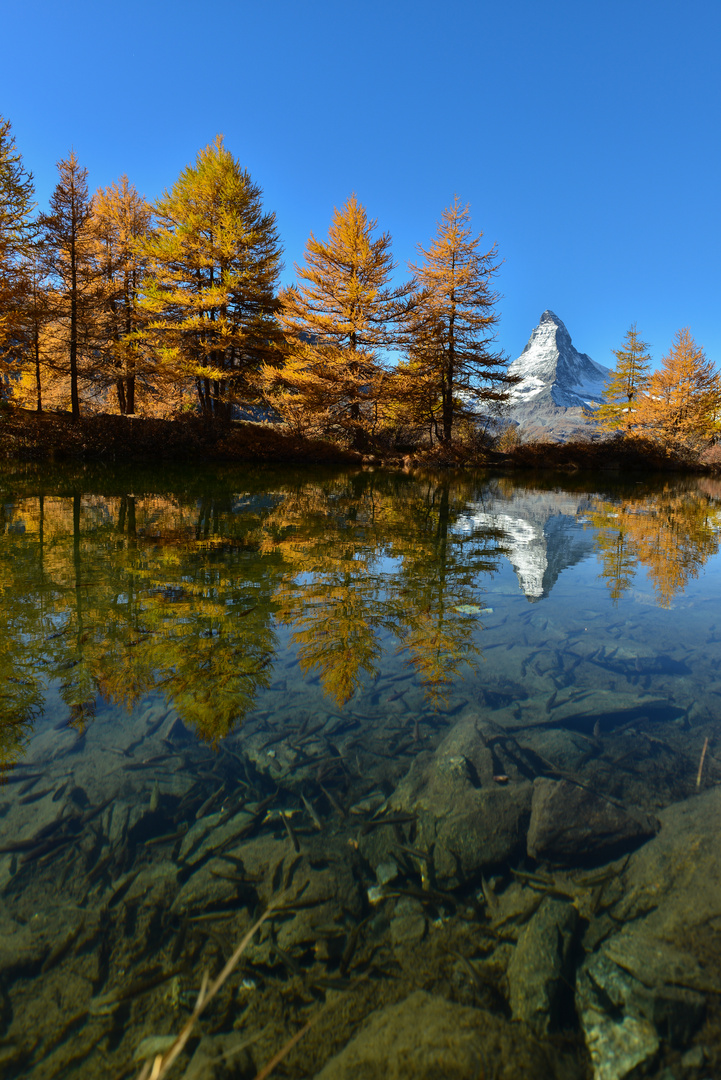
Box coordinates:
[316,990,555,1080]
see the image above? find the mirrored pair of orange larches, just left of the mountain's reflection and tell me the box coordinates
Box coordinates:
[264,475,501,704]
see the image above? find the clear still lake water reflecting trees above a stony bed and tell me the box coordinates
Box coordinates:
[0,469,721,1078]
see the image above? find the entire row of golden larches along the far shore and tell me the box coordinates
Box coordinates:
[0,117,721,468]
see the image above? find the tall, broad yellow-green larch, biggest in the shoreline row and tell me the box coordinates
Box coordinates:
[136,135,282,419]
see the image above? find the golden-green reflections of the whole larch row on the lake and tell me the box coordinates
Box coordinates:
[0,471,720,769]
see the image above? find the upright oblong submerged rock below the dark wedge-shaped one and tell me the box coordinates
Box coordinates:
[507,896,579,1035]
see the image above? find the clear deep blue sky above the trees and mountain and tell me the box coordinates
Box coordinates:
[0,0,721,366]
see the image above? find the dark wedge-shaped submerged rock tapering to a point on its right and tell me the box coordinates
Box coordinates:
[528,777,657,863]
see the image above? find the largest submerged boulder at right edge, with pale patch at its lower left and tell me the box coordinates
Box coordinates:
[576,788,721,1080]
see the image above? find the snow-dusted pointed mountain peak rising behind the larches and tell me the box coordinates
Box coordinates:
[508,311,610,442]
